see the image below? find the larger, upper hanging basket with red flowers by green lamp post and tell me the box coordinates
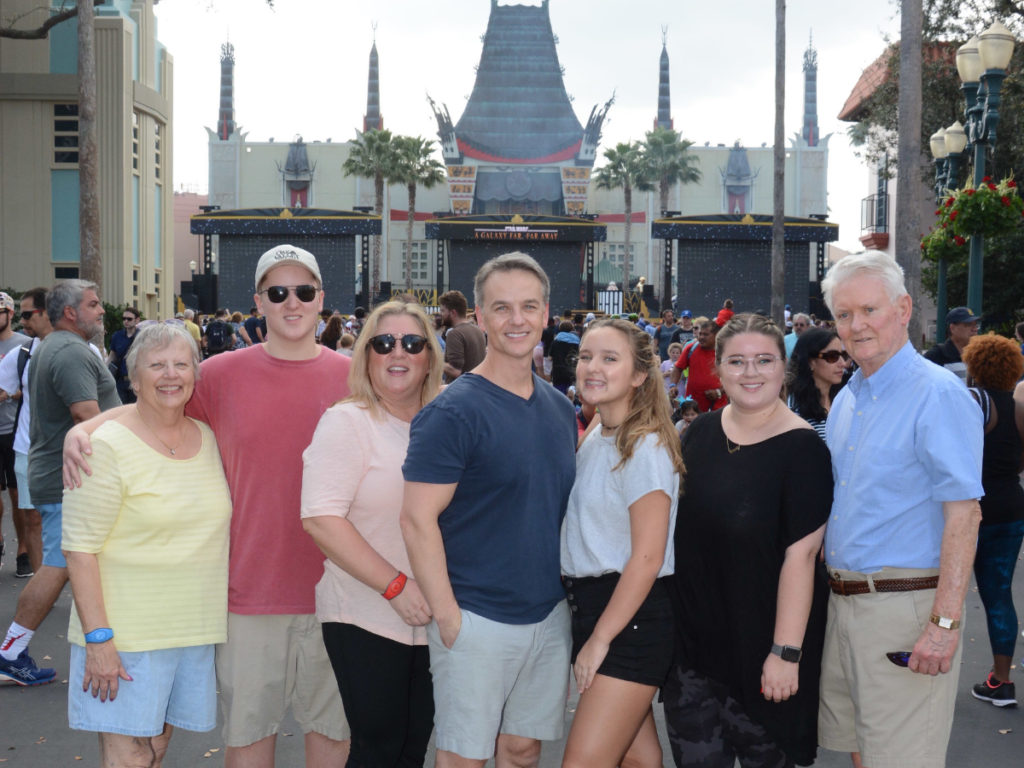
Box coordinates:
[936,176,1024,238]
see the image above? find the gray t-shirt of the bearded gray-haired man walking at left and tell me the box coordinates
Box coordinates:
[29,331,121,504]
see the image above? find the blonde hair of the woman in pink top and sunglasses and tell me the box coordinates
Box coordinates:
[340,301,444,421]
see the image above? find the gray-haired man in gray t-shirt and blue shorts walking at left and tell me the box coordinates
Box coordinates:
[0,280,121,685]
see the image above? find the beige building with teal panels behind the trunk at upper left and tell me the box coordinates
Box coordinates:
[0,0,174,317]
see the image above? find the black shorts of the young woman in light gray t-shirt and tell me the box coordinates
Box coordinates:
[562,573,675,687]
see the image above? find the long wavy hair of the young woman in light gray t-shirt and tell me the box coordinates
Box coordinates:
[587,317,686,493]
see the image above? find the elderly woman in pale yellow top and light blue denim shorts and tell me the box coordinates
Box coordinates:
[62,322,231,768]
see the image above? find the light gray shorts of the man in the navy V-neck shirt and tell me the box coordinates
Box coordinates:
[427,600,572,760]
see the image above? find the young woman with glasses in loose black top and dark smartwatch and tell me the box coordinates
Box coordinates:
[665,314,833,768]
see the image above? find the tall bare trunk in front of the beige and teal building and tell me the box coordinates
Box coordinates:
[78,0,100,290]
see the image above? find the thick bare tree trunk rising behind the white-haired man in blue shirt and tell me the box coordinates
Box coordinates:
[896,0,929,347]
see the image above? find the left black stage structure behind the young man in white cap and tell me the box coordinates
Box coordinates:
[190,208,381,314]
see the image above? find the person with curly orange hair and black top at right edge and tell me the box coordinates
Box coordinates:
[963,335,1024,707]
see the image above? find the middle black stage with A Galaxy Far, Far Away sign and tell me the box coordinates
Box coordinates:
[426,214,608,314]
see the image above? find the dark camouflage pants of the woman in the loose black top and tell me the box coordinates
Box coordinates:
[665,665,793,768]
